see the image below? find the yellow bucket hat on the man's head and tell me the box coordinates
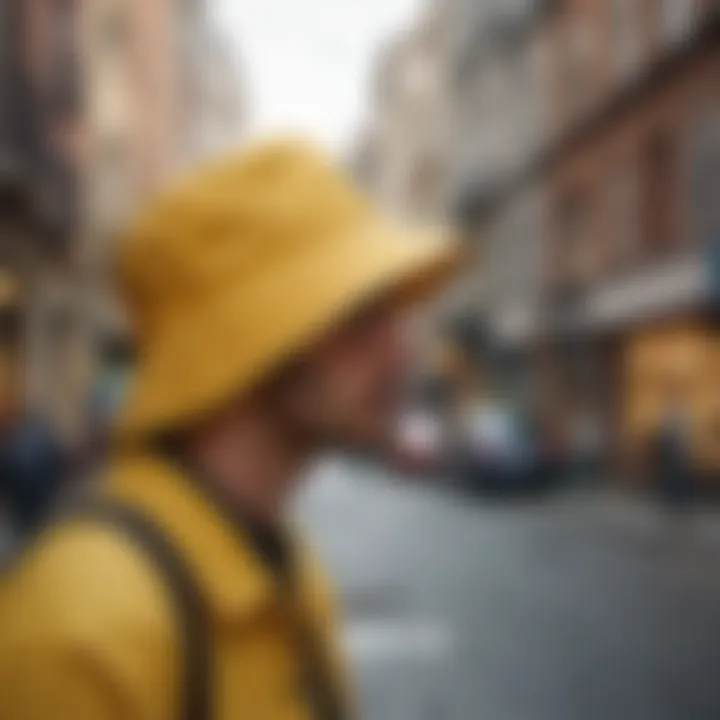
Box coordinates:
[118,140,457,437]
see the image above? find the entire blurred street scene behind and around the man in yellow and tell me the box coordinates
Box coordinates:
[0,0,720,720]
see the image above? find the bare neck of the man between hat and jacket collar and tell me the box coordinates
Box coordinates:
[187,410,309,523]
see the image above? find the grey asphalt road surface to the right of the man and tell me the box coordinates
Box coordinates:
[299,460,720,720]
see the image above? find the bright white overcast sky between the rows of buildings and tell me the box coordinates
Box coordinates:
[213,0,418,151]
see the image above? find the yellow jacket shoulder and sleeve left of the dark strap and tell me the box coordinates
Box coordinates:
[0,522,181,718]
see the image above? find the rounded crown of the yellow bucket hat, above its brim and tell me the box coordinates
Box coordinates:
[119,141,371,329]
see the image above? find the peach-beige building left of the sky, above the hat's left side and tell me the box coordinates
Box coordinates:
[83,0,212,258]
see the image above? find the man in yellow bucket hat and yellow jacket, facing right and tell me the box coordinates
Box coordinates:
[0,141,454,720]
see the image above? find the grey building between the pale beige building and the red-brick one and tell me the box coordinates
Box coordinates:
[448,0,552,402]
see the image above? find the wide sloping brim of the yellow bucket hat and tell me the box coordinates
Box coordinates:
[117,222,460,438]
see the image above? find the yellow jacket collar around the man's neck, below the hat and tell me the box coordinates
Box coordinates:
[106,452,283,617]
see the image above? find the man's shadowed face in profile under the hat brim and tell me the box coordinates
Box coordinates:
[276,292,412,449]
